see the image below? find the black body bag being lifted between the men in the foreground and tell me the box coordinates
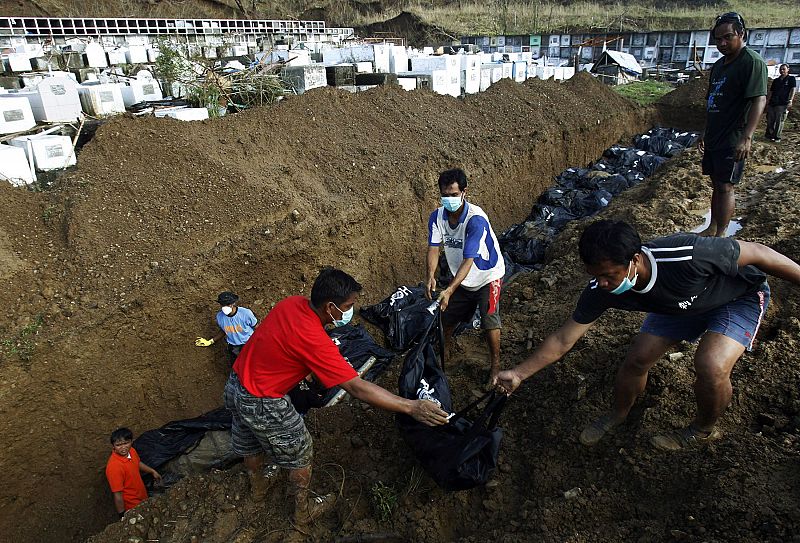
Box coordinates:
[397,312,506,491]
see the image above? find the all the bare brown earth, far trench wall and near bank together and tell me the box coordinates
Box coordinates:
[0,76,800,543]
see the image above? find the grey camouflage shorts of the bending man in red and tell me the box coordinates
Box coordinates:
[224,371,313,469]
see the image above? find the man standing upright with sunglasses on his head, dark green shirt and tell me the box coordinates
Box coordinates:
[697,12,767,237]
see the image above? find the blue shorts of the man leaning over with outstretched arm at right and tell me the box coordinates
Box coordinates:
[640,282,769,351]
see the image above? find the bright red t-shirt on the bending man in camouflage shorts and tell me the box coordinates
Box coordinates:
[233,296,358,398]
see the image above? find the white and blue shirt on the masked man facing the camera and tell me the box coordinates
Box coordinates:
[428,201,506,290]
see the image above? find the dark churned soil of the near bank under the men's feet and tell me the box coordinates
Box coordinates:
[91,115,800,543]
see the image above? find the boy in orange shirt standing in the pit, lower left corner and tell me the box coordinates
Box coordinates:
[106,428,161,518]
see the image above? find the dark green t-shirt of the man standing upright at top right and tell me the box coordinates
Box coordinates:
[704,47,767,150]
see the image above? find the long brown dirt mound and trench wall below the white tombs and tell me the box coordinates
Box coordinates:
[0,74,646,542]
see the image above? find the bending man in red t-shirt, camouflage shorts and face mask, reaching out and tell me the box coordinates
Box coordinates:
[225,268,447,532]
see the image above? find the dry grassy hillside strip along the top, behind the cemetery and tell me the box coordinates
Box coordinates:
[6,0,800,38]
